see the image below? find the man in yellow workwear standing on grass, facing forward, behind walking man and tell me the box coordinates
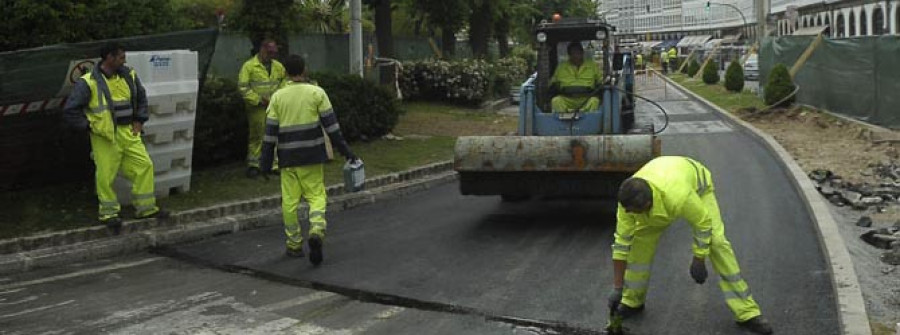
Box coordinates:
[238,39,285,178]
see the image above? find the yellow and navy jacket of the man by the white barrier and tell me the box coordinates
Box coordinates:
[64,65,150,141]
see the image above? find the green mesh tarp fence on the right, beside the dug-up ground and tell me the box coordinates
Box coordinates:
[759,36,900,129]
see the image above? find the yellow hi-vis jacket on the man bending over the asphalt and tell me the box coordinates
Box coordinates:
[613,156,714,260]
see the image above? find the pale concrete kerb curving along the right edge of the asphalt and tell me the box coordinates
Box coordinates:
[653,71,872,335]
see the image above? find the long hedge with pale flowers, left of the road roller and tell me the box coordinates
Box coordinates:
[400,57,528,106]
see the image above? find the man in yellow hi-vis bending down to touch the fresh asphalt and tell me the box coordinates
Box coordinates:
[609,156,772,334]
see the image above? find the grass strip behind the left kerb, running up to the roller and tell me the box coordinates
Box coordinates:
[0,103,516,238]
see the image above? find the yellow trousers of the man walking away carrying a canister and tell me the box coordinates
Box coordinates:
[279,164,328,250]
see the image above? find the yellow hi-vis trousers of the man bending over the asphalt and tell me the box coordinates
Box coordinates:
[622,190,760,321]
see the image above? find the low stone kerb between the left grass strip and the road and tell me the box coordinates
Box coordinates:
[0,161,457,275]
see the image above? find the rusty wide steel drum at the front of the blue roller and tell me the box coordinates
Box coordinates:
[454,134,660,198]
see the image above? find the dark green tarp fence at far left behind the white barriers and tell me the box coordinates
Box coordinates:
[0,30,218,190]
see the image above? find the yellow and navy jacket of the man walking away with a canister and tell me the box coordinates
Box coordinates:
[260,82,353,171]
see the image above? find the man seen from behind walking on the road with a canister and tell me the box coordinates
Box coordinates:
[260,55,358,265]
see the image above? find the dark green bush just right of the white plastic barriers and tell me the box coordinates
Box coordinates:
[193,75,247,168]
